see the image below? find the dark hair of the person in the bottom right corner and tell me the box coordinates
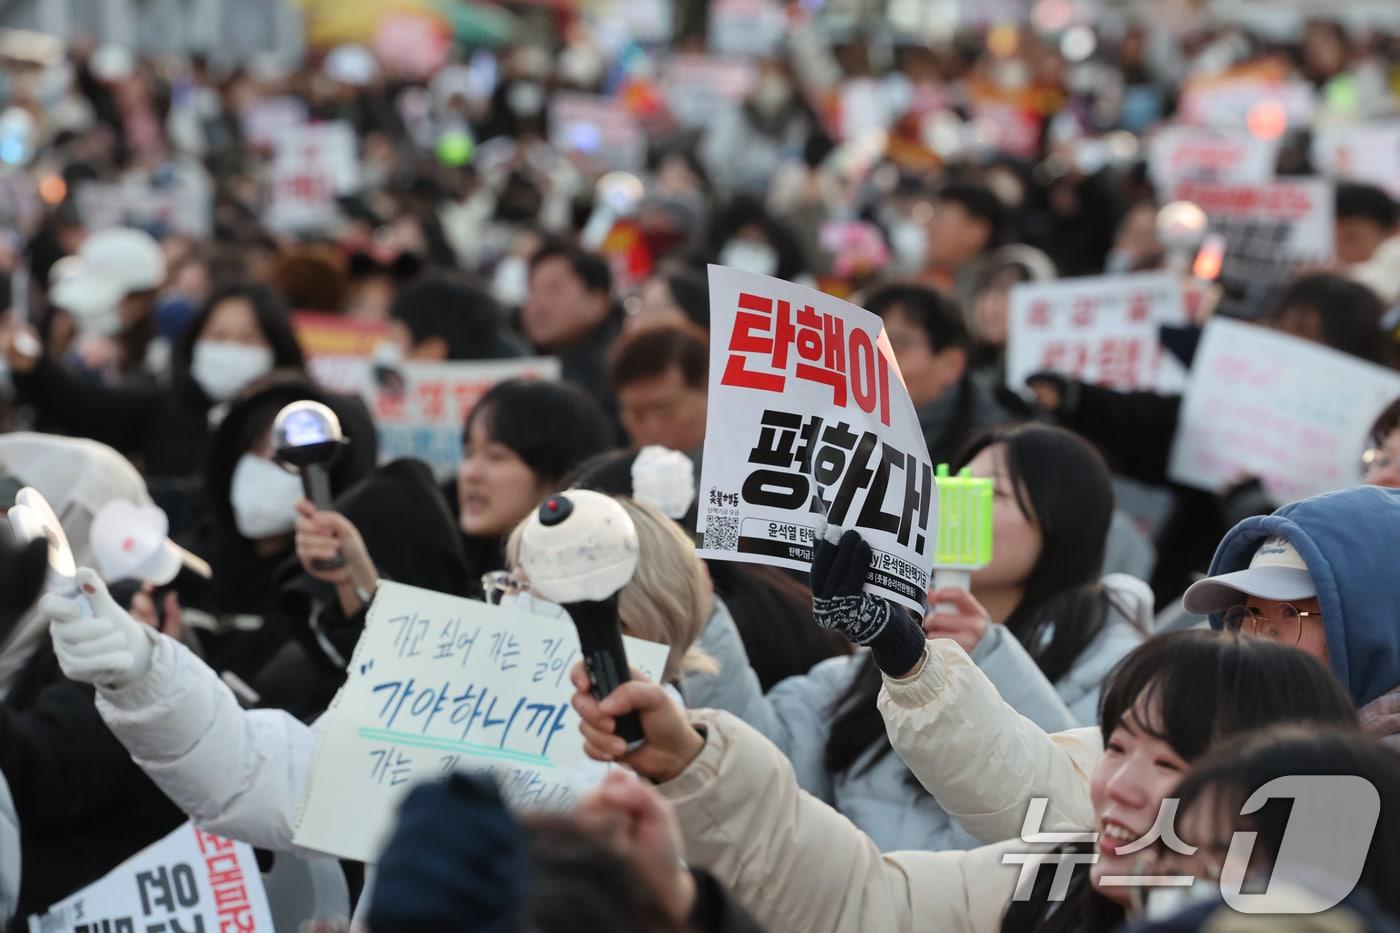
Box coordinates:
[1176,726,1400,916]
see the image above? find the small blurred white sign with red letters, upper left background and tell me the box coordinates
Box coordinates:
[263,120,360,233]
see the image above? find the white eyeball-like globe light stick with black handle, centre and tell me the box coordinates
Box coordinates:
[521,489,644,751]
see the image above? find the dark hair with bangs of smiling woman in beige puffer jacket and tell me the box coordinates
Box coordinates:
[1001,629,1358,933]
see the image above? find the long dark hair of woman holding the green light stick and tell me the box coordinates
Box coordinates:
[826,424,1126,772]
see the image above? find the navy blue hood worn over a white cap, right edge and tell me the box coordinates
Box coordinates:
[1210,486,1400,706]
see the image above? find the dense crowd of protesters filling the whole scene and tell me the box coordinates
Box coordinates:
[0,0,1400,933]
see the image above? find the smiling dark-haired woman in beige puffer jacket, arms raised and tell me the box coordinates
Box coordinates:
[573,621,1357,930]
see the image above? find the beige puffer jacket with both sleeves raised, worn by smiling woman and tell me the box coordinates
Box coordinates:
[659,639,1102,933]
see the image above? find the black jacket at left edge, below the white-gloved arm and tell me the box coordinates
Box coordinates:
[0,639,185,919]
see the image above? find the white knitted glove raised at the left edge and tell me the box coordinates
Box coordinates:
[39,567,155,689]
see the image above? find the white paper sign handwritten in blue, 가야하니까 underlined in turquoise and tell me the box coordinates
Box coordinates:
[295,583,669,862]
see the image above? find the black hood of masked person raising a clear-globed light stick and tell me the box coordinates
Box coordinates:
[204,377,379,539]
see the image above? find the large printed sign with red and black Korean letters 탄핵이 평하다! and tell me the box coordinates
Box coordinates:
[700,266,938,611]
